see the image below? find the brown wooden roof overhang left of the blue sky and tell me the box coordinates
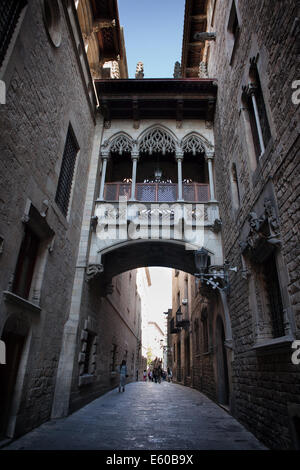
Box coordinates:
[91,0,122,62]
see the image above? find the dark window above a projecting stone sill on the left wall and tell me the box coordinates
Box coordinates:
[12,227,40,299]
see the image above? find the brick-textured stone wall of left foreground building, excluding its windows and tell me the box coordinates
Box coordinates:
[0,0,94,434]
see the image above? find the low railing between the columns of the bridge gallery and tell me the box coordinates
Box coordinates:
[104,183,210,202]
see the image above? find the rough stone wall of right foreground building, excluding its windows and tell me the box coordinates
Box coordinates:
[209,0,300,448]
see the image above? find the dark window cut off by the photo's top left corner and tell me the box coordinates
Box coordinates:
[0,0,27,67]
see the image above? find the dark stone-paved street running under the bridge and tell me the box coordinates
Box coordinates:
[4,382,265,450]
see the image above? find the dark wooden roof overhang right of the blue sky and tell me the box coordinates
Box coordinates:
[181,0,207,78]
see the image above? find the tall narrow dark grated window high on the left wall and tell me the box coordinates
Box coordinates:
[55,126,79,216]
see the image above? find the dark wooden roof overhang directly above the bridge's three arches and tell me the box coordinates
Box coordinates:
[95,78,217,121]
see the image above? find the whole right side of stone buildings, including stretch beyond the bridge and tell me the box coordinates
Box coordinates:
[170,0,300,448]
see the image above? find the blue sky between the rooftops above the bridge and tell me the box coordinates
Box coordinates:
[118,0,185,78]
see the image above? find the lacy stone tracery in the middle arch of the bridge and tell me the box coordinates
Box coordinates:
[138,124,179,155]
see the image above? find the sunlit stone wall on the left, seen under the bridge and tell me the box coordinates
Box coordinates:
[70,270,141,411]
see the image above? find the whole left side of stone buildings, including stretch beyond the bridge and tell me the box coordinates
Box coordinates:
[0,0,141,437]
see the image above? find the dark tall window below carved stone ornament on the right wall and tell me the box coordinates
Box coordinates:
[262,253,285,338]
